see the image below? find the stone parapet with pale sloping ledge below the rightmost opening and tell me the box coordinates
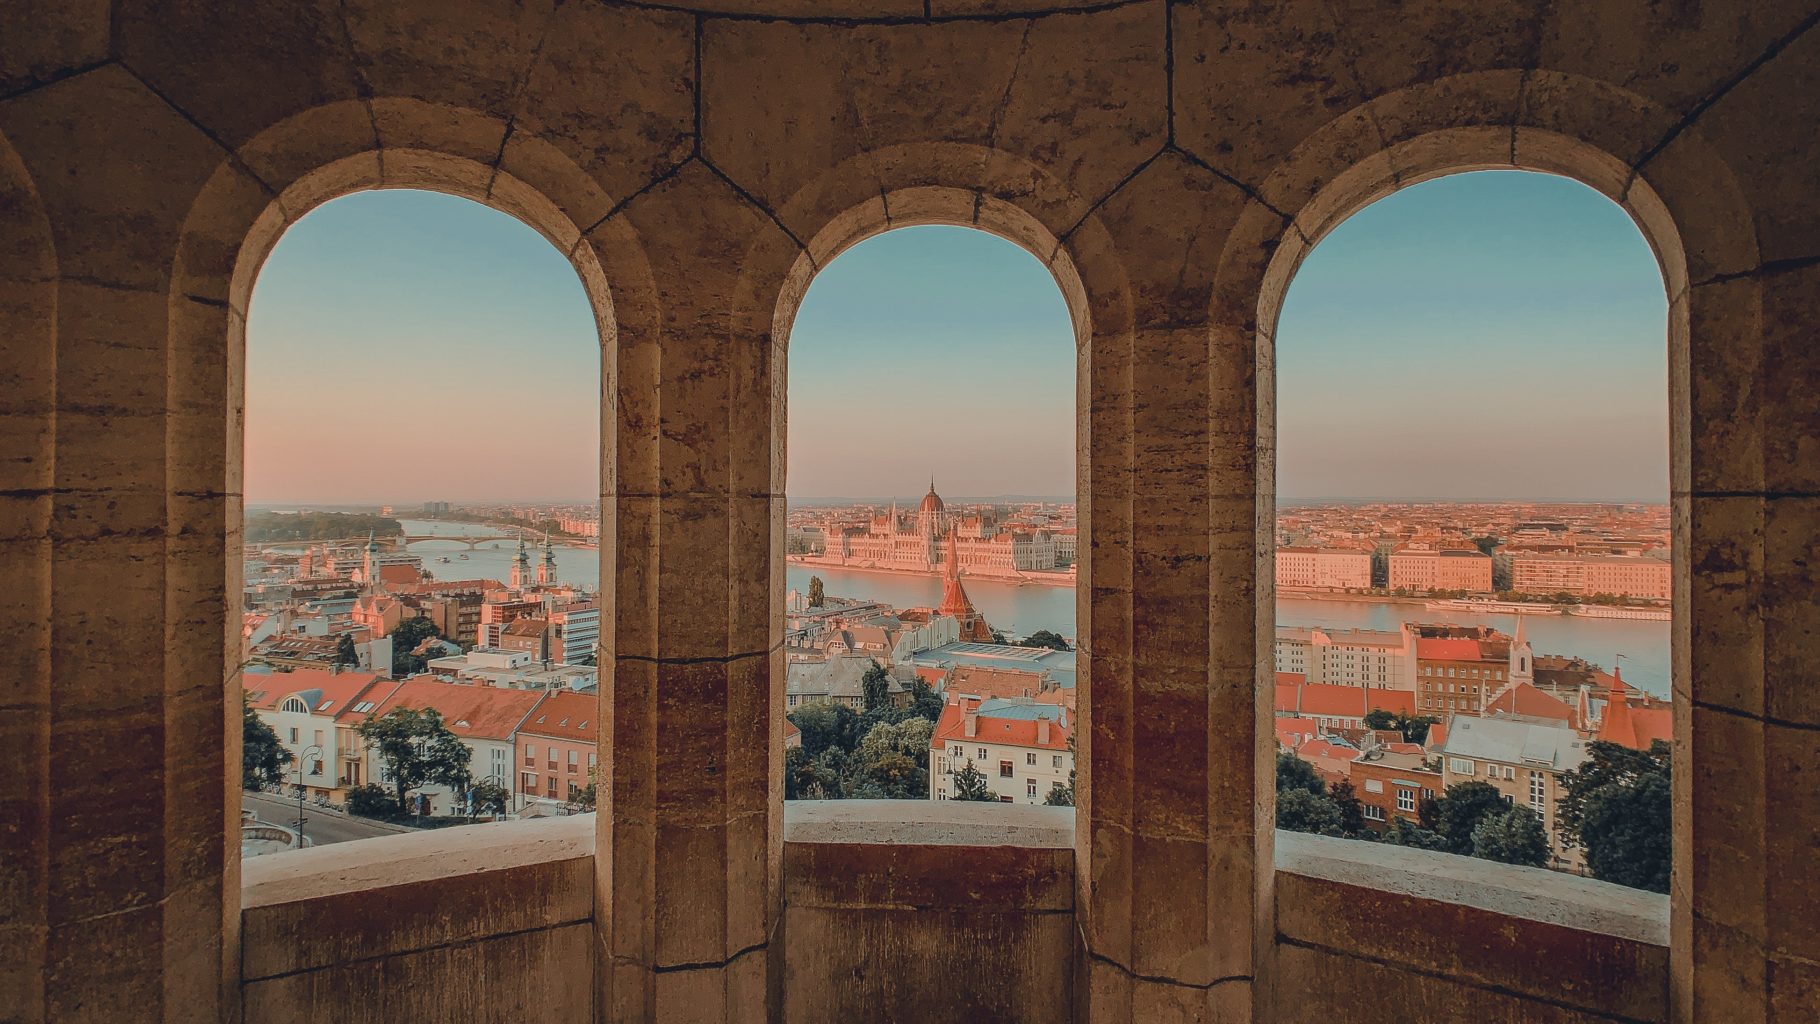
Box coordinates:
[1276,831,1669,1020]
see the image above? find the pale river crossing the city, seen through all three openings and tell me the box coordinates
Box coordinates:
[384,518,1669,697]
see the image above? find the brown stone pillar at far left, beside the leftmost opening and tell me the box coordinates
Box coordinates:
[0,65,242,1020]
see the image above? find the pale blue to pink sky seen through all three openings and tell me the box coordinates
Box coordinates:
[248,173,1667,504]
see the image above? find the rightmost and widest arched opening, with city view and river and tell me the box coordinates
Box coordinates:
[1259,171,1685,893]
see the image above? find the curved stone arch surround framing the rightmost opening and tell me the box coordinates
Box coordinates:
[1212,71,1764,1020]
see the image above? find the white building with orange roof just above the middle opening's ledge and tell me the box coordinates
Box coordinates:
[928,697,1074,804]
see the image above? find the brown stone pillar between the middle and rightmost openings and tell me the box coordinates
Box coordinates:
[1067,153,1281,1024]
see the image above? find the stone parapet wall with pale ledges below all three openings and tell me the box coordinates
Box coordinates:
[242,814,1669,1024]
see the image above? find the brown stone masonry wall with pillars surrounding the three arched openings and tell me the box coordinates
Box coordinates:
[0,0,1820,1022]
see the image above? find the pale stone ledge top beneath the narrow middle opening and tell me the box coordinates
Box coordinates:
[784,800,1074,851]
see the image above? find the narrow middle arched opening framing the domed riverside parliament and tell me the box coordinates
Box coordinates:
[779,226,1087,818]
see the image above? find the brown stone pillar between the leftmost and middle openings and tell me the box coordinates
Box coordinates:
[582,160,797,1022]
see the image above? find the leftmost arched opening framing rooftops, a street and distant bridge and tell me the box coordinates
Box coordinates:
[233,189,612,853]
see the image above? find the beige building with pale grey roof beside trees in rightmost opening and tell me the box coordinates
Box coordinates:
[1441,715,1587,868]
